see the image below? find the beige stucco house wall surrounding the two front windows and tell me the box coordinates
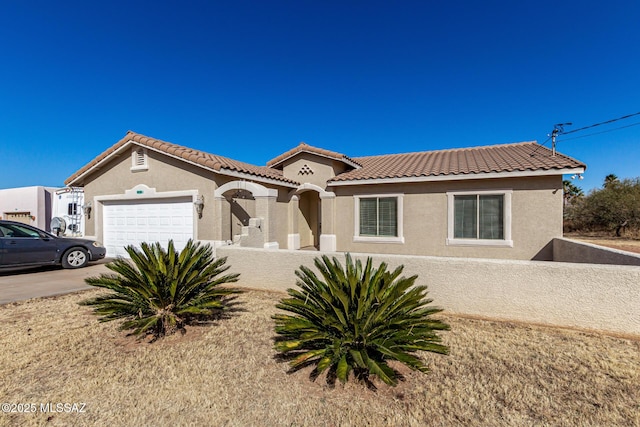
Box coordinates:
[329,176,562,260]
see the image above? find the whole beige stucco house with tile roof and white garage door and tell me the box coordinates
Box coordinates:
[65,132,586,260]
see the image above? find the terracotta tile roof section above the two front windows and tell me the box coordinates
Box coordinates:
[331,142,586,182]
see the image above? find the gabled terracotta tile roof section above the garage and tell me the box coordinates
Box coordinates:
[65,131,299,185]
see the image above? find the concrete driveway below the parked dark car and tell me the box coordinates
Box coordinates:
[0,259,111,304]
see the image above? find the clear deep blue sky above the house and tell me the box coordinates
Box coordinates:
[0,0,640,191]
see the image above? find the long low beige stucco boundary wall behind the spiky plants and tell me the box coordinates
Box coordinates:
[216,247,640,335]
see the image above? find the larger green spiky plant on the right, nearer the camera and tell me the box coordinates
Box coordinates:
[273,254,449,386]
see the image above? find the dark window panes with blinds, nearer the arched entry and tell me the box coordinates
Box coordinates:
[360,197,398,237]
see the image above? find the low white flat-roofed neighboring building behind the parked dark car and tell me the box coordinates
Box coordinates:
[0,186,55,231]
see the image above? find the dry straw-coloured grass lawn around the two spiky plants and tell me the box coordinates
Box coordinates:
[0,291,640,427]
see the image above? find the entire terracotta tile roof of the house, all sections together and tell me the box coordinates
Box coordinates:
[65,131,586,190]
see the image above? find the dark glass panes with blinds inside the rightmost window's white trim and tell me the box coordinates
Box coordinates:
[453,194,504,240]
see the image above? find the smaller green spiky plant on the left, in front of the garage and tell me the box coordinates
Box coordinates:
[80,240,240,340]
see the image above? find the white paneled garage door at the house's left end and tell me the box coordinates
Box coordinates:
[102,197,193,257]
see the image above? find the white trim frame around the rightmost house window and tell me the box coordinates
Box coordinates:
[447,190,513,248]
